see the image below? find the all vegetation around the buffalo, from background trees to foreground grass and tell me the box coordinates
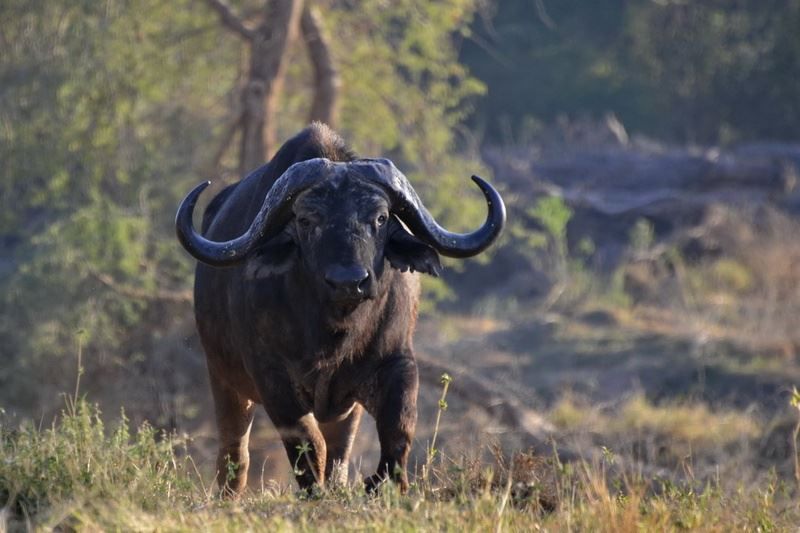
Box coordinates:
[0,0,800,531]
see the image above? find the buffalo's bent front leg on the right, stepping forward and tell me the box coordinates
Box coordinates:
[365,356,419,492]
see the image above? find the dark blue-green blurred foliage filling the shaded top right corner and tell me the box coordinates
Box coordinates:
[461,0,800,143]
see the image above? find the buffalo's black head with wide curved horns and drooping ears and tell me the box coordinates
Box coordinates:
[176,158,506,305]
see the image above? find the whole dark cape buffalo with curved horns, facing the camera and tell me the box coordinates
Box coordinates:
[176,123,506,495]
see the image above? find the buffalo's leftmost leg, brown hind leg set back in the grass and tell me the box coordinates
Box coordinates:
[211,375,254,497]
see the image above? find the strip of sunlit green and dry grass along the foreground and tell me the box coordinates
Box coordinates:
[0,401,800,531]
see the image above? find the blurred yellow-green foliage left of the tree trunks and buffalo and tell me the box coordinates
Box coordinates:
[0,0,235,418]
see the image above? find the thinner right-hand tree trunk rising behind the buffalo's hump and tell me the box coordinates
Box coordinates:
[300,5,342,128]
